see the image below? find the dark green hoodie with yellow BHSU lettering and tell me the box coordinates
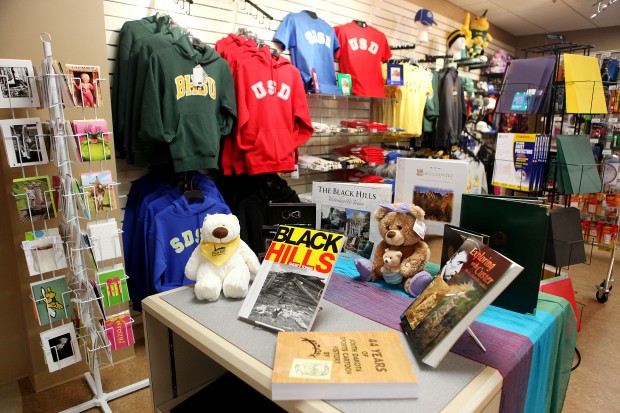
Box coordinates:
[139,36,237,172]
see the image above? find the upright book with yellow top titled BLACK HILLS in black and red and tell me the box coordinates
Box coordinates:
[239,225,344,331]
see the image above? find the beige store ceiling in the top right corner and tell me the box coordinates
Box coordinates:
[448,0,620,37]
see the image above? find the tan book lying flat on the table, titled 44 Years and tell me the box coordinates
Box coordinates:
[271,331,419,400]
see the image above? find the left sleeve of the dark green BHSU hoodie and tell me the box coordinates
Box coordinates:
[138,55,175,143]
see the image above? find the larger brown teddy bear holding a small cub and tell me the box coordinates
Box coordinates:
[371,203,431,292]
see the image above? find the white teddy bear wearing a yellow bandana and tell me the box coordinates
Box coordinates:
[185,214,260,301]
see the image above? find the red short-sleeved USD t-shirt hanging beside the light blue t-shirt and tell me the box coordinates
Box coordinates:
[334,22,392,97]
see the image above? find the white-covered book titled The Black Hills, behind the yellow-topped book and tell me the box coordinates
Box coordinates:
[312,181,392,259]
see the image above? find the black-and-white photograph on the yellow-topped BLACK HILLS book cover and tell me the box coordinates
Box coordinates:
[248,263,326,331]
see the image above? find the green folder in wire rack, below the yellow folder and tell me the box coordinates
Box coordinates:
[556,135,603,194]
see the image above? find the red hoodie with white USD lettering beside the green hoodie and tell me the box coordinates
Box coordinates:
[231,46,314,175]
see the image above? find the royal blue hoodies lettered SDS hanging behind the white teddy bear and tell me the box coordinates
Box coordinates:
[122,173,230,311]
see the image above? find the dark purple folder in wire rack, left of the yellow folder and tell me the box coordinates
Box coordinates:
[495,56,555,114]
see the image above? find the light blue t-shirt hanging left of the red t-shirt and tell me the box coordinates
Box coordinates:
[273,11,340,94]
